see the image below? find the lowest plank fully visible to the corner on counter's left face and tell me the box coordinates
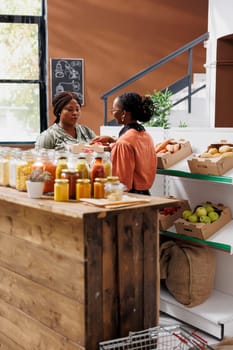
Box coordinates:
[0,267,85,345]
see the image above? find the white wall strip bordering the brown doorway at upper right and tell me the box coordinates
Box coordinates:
[206,0,233,127]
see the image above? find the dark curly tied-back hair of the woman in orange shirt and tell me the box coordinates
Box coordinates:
[118,92,154,123]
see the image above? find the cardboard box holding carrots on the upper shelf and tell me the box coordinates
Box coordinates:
[157,139,192,169]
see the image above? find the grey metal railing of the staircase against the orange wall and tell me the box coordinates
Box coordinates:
[101,32,209,125]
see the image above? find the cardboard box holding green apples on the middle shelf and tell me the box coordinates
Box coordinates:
[174,204,232,239]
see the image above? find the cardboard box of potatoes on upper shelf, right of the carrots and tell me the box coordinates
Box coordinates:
[188,143,233,176]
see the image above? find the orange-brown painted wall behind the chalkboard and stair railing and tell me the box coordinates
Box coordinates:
[47,0,208,133]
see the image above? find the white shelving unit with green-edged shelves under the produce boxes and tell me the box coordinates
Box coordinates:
[157,130,233,339]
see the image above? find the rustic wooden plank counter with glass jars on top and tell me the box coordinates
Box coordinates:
[0,187,177,350]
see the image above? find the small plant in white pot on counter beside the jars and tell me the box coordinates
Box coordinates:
[26,168,51,198]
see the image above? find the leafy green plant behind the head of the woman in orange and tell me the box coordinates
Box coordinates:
[144,89,172,129]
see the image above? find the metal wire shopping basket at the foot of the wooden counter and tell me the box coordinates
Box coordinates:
[99,325,213,350]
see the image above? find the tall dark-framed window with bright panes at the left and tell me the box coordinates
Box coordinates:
[0,0,47,144]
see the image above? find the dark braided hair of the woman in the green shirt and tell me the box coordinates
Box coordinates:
[52,91,81,124]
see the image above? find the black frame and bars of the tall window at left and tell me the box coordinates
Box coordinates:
[0,0,48,145]
